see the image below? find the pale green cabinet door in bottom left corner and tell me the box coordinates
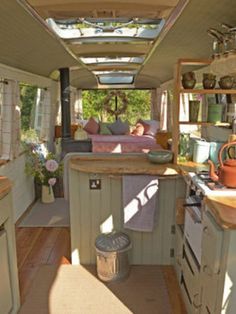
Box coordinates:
[0,231,12,314]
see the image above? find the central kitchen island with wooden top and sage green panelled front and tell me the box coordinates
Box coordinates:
[67,153,186,265]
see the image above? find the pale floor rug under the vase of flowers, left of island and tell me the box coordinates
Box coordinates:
[18,198,70,227]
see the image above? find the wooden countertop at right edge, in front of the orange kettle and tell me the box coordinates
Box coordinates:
[204,196,236,229]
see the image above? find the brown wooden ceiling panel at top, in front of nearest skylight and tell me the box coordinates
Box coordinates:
[28,0,178,19]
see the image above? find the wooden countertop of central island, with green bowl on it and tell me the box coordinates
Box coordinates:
[70,154,180,176]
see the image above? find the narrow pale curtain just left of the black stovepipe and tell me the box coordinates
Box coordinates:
[39,89,52,142]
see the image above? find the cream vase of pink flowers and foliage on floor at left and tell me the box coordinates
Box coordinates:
[26,144,62,203]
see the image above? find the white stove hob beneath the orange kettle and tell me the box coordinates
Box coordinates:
[188,171,236,196]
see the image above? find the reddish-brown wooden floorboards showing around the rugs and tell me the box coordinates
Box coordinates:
[16,227,186,314]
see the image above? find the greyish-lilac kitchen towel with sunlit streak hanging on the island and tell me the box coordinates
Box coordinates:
[122,175,158,232]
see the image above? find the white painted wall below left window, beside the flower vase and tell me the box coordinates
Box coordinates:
[0,154,34,222]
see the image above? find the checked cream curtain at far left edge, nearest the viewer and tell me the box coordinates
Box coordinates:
[0,80,21,160]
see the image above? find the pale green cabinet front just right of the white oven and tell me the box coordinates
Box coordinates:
[202,212,223,274]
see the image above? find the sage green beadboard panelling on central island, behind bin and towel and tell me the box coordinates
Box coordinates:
[70,169,184,265]
